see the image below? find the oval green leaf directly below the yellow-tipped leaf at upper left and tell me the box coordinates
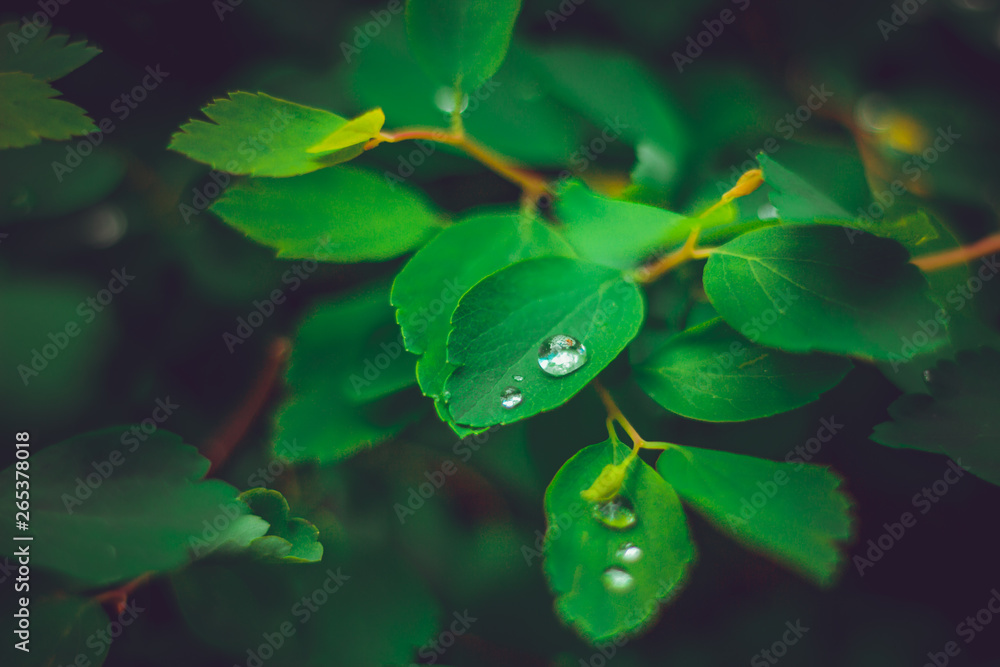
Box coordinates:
[211,167,440,262]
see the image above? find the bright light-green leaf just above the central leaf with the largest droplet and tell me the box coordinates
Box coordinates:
[555,180,696,269]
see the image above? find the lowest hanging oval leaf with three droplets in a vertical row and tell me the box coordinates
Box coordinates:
[545,440,695,643]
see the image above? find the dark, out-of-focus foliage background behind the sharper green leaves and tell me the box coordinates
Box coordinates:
[0,0,1000,667]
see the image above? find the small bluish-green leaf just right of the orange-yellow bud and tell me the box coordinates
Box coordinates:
[757,144,871,222]
